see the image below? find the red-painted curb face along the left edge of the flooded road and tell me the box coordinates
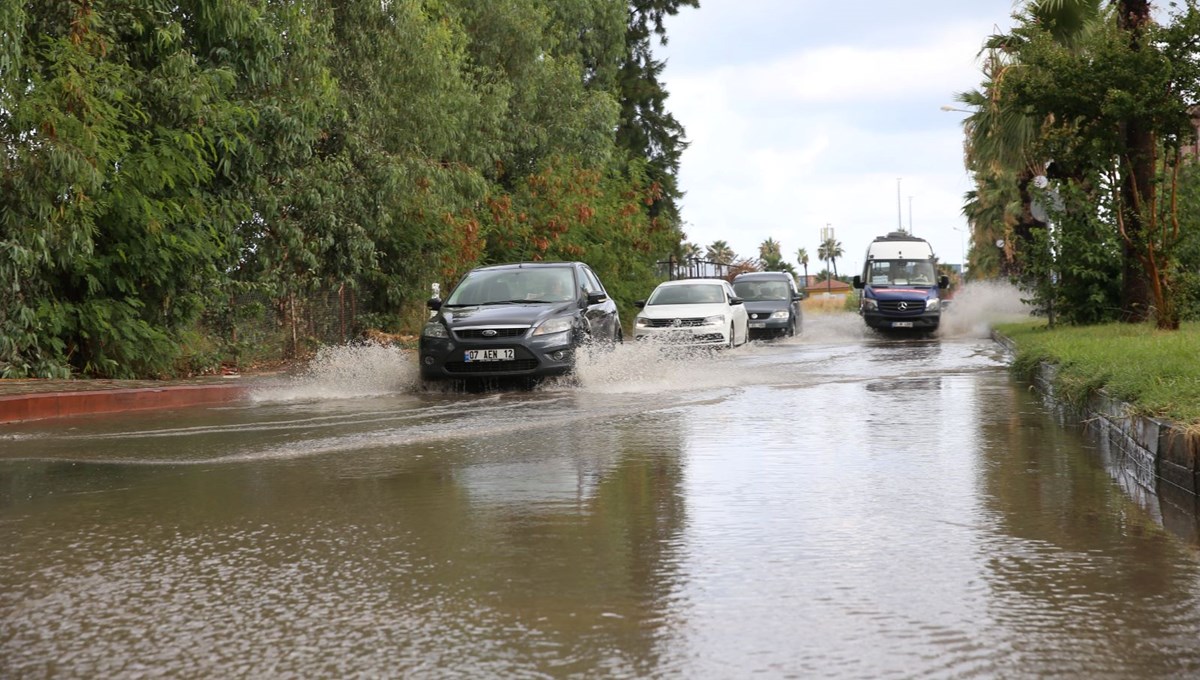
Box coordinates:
[0,385,250,423]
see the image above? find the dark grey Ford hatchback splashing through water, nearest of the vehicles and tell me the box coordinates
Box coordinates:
[420,261,622,380]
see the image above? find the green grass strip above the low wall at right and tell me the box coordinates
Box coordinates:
[995,321,1200,429]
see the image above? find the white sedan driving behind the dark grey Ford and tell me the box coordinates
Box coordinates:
[634,278,749,348]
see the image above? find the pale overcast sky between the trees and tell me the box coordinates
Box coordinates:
[656,0,1014,275]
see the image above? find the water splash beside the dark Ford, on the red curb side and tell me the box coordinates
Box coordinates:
[251,343,420,402]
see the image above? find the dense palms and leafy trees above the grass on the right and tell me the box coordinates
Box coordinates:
[959,0,1200,329]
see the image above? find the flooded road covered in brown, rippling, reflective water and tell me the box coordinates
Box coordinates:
[0,296,1200,678]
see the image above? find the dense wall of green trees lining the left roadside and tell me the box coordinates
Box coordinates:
[0,0,697,377]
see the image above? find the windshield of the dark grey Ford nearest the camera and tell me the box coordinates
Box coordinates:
[445,266,578,307]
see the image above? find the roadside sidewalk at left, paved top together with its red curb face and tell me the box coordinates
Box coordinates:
[0,375,257,425]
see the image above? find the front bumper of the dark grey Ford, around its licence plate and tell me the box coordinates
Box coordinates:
[418,332,575,380]
